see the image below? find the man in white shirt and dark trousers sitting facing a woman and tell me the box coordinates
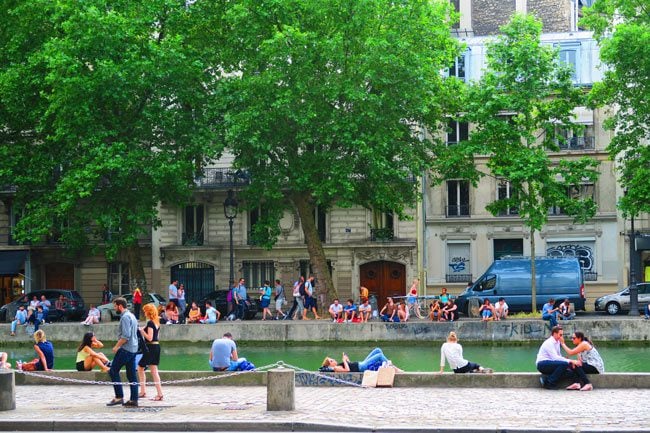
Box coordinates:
[535,326,580,389]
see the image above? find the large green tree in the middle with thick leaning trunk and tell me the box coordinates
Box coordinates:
[197,0,458,297]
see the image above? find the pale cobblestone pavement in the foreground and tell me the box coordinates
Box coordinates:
[5,385,650,431]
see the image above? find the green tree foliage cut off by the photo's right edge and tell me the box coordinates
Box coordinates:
[582,0,650,217]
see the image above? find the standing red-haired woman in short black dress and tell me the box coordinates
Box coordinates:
[138,304,163,401]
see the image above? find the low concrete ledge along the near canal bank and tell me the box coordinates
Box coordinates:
[16,370,650,389]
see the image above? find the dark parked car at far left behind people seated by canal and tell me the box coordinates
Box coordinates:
[0,289,87,322]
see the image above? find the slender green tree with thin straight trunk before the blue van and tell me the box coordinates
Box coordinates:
[428,14,598,311]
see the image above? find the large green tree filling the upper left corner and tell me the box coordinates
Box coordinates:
[0,0,221,285]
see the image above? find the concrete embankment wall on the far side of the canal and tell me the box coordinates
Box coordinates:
[0,316,650,347]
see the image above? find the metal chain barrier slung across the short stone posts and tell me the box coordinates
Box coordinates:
[14,361,361,387]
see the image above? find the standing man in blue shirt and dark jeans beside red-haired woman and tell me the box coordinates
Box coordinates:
[106,298,138,407]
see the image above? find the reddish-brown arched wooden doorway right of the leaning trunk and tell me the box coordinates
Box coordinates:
[359,260,406,302]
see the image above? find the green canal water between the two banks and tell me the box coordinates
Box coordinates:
[0,342,650,373]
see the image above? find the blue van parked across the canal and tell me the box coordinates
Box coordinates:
[456,257,585,314]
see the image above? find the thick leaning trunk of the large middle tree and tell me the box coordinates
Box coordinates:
[291,193,338,302]
